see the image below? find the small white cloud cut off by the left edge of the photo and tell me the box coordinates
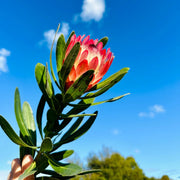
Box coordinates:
[0,48,11,72]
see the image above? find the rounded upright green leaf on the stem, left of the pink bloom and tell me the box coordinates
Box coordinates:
[35,63,54,99]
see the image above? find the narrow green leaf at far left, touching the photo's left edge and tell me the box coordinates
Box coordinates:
[0,115,37,149]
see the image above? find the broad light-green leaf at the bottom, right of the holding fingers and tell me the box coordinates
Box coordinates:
[48,158,82,176]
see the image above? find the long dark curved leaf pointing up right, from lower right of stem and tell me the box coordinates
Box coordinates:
[54,111,97,146]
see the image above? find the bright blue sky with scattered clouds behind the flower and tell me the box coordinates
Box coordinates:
[0,0,180,180]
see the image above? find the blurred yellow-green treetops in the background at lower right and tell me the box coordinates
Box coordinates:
[72,149,170,180]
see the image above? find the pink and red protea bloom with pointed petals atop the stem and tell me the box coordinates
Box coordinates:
[65,34,114,91]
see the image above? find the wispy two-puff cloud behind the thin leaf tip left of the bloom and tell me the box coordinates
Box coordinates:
[39,22,70,49]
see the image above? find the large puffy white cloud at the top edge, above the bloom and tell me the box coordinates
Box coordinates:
[80,0,105,21]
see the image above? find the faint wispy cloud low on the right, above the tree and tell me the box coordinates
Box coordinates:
[138,104,166,118]
